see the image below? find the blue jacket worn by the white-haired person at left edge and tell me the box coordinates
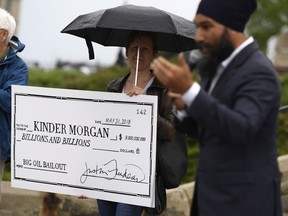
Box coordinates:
[0,36,28,161]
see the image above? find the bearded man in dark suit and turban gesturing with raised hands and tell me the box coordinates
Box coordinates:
[152,0,282,216]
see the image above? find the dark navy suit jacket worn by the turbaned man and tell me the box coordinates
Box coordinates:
[179,42,282,216]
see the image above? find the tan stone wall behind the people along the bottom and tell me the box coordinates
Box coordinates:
[0,155,288,216]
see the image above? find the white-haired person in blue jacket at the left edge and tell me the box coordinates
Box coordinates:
[0,8,28,201]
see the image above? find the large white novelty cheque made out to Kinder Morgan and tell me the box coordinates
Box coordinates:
[11,86,157,207]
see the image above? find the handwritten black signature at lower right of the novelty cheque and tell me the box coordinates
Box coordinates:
[80,159,145,184]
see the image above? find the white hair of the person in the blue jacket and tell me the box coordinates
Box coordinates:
[0,8,16,42]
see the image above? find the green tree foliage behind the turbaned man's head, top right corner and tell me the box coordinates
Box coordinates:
[247,0,288,51]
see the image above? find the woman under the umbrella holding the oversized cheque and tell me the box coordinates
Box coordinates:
[79,31,184,216]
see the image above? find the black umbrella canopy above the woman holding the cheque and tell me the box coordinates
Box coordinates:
[61,5,196,59]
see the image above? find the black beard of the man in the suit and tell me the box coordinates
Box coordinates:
[197,28,234,78]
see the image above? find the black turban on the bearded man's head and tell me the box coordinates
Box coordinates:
[196,0,257,32]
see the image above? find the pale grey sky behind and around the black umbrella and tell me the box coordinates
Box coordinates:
[18,0,200,67]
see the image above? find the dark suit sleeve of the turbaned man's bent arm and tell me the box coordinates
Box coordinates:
[187,59,280,144]
